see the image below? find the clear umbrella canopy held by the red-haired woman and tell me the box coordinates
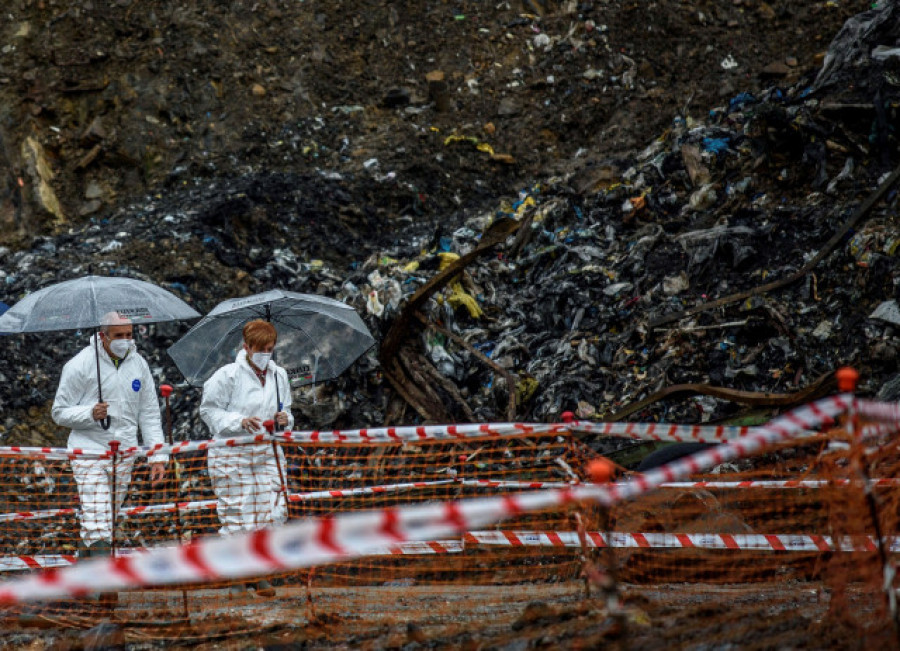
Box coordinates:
[169,289,375,386]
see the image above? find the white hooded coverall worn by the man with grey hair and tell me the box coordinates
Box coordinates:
[51,336,168,546]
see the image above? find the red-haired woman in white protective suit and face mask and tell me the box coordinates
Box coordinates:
[200,320,294,596]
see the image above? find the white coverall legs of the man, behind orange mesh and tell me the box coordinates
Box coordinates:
[70,457,134,546]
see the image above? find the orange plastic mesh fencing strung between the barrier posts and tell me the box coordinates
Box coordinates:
[0,422,900,648]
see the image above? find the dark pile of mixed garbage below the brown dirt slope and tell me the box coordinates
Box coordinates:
[0,3,900,445]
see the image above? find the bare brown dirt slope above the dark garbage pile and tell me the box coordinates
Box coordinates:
[0,0,869,252]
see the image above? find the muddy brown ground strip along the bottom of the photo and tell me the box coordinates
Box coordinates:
[0,582,891,651]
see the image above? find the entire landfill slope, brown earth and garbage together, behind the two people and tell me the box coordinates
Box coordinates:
[0,0,900,456]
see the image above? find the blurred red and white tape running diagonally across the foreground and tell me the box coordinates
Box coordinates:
[0,395,852,603]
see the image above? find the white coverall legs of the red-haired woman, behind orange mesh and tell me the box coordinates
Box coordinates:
[208,443,287,535]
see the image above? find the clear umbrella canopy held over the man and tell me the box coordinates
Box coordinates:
[0,276,200,334]
